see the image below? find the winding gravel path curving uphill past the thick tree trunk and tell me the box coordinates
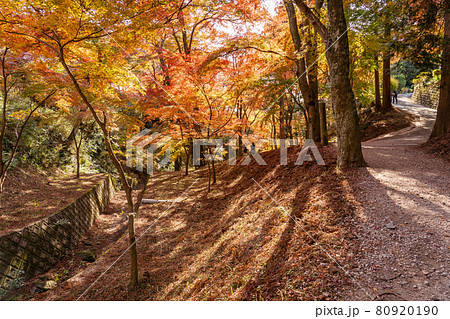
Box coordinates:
[345,96,450,300]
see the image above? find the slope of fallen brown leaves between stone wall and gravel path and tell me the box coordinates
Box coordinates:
[25,146,357,300]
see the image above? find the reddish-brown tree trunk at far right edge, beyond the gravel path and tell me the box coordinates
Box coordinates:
[430,1,450,138]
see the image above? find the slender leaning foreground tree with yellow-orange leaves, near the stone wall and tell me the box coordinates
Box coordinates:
[0,1,171,287]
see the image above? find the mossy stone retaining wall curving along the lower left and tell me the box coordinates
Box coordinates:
[0,176,114,289]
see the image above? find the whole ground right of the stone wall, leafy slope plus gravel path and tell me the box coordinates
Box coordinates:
[2,98,450,300]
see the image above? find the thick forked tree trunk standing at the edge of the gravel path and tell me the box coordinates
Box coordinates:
[295,0,365,168]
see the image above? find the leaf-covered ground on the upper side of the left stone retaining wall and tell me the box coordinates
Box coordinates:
[0,172,105,235]
